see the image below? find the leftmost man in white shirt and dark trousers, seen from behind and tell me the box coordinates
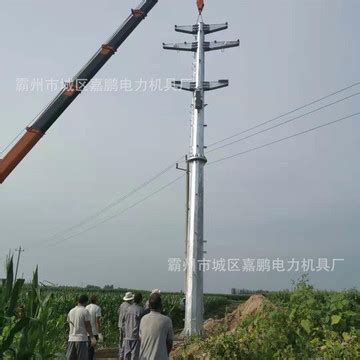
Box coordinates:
[66,295,96,360]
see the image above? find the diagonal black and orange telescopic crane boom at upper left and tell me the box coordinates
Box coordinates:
[0,0,158,184]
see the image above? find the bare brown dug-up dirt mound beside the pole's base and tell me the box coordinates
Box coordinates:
[170,295,270,360]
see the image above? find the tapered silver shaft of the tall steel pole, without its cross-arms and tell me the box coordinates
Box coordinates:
[185,22,206,335]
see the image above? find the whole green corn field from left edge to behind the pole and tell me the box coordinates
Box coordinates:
[0,259,240,360]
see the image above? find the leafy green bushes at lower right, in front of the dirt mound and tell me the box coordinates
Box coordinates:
[202,278,360,360]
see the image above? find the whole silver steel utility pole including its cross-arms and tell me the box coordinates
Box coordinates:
[163,0,240,336]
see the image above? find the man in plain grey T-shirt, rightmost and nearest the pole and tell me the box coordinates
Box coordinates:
[140,294,174,360]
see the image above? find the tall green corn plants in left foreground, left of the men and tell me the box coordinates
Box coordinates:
[0,258,65,360]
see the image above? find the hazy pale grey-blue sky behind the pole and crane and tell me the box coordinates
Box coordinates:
[0,0,360,292]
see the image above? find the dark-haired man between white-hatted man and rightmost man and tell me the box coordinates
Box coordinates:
[124,293,144,360]
